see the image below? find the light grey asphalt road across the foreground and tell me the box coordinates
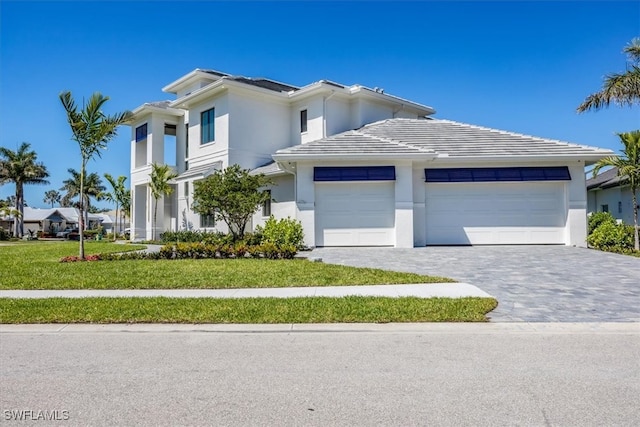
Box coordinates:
[0,323,640,426]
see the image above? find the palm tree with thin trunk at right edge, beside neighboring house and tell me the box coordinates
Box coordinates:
[593,130,640,251]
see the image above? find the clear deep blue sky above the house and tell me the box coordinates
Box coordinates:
[0,0,640,207]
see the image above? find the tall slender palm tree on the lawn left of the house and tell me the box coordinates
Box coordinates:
[60,91,132,259]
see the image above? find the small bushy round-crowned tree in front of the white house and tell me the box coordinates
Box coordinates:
[192,165,273,240]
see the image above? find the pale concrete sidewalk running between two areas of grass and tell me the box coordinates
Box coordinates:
[0,283,493,298]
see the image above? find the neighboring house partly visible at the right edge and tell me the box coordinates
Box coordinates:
[587,168,640,224]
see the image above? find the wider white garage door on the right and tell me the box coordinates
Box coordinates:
[426,182,566,245]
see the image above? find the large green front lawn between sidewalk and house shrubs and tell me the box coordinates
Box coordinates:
[0,241,452,289]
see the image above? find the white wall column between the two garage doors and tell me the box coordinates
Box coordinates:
[395,161,414,248]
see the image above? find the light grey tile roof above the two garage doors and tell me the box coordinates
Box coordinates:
[276,118,612,158]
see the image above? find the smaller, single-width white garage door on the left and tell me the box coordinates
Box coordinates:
[315,182,395,246]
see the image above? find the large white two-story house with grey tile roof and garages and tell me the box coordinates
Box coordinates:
[129,69,612,247]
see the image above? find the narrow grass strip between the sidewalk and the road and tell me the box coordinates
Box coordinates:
[0,296,497,324]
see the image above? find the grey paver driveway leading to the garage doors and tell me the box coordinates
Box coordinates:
[311,246,640,322]
